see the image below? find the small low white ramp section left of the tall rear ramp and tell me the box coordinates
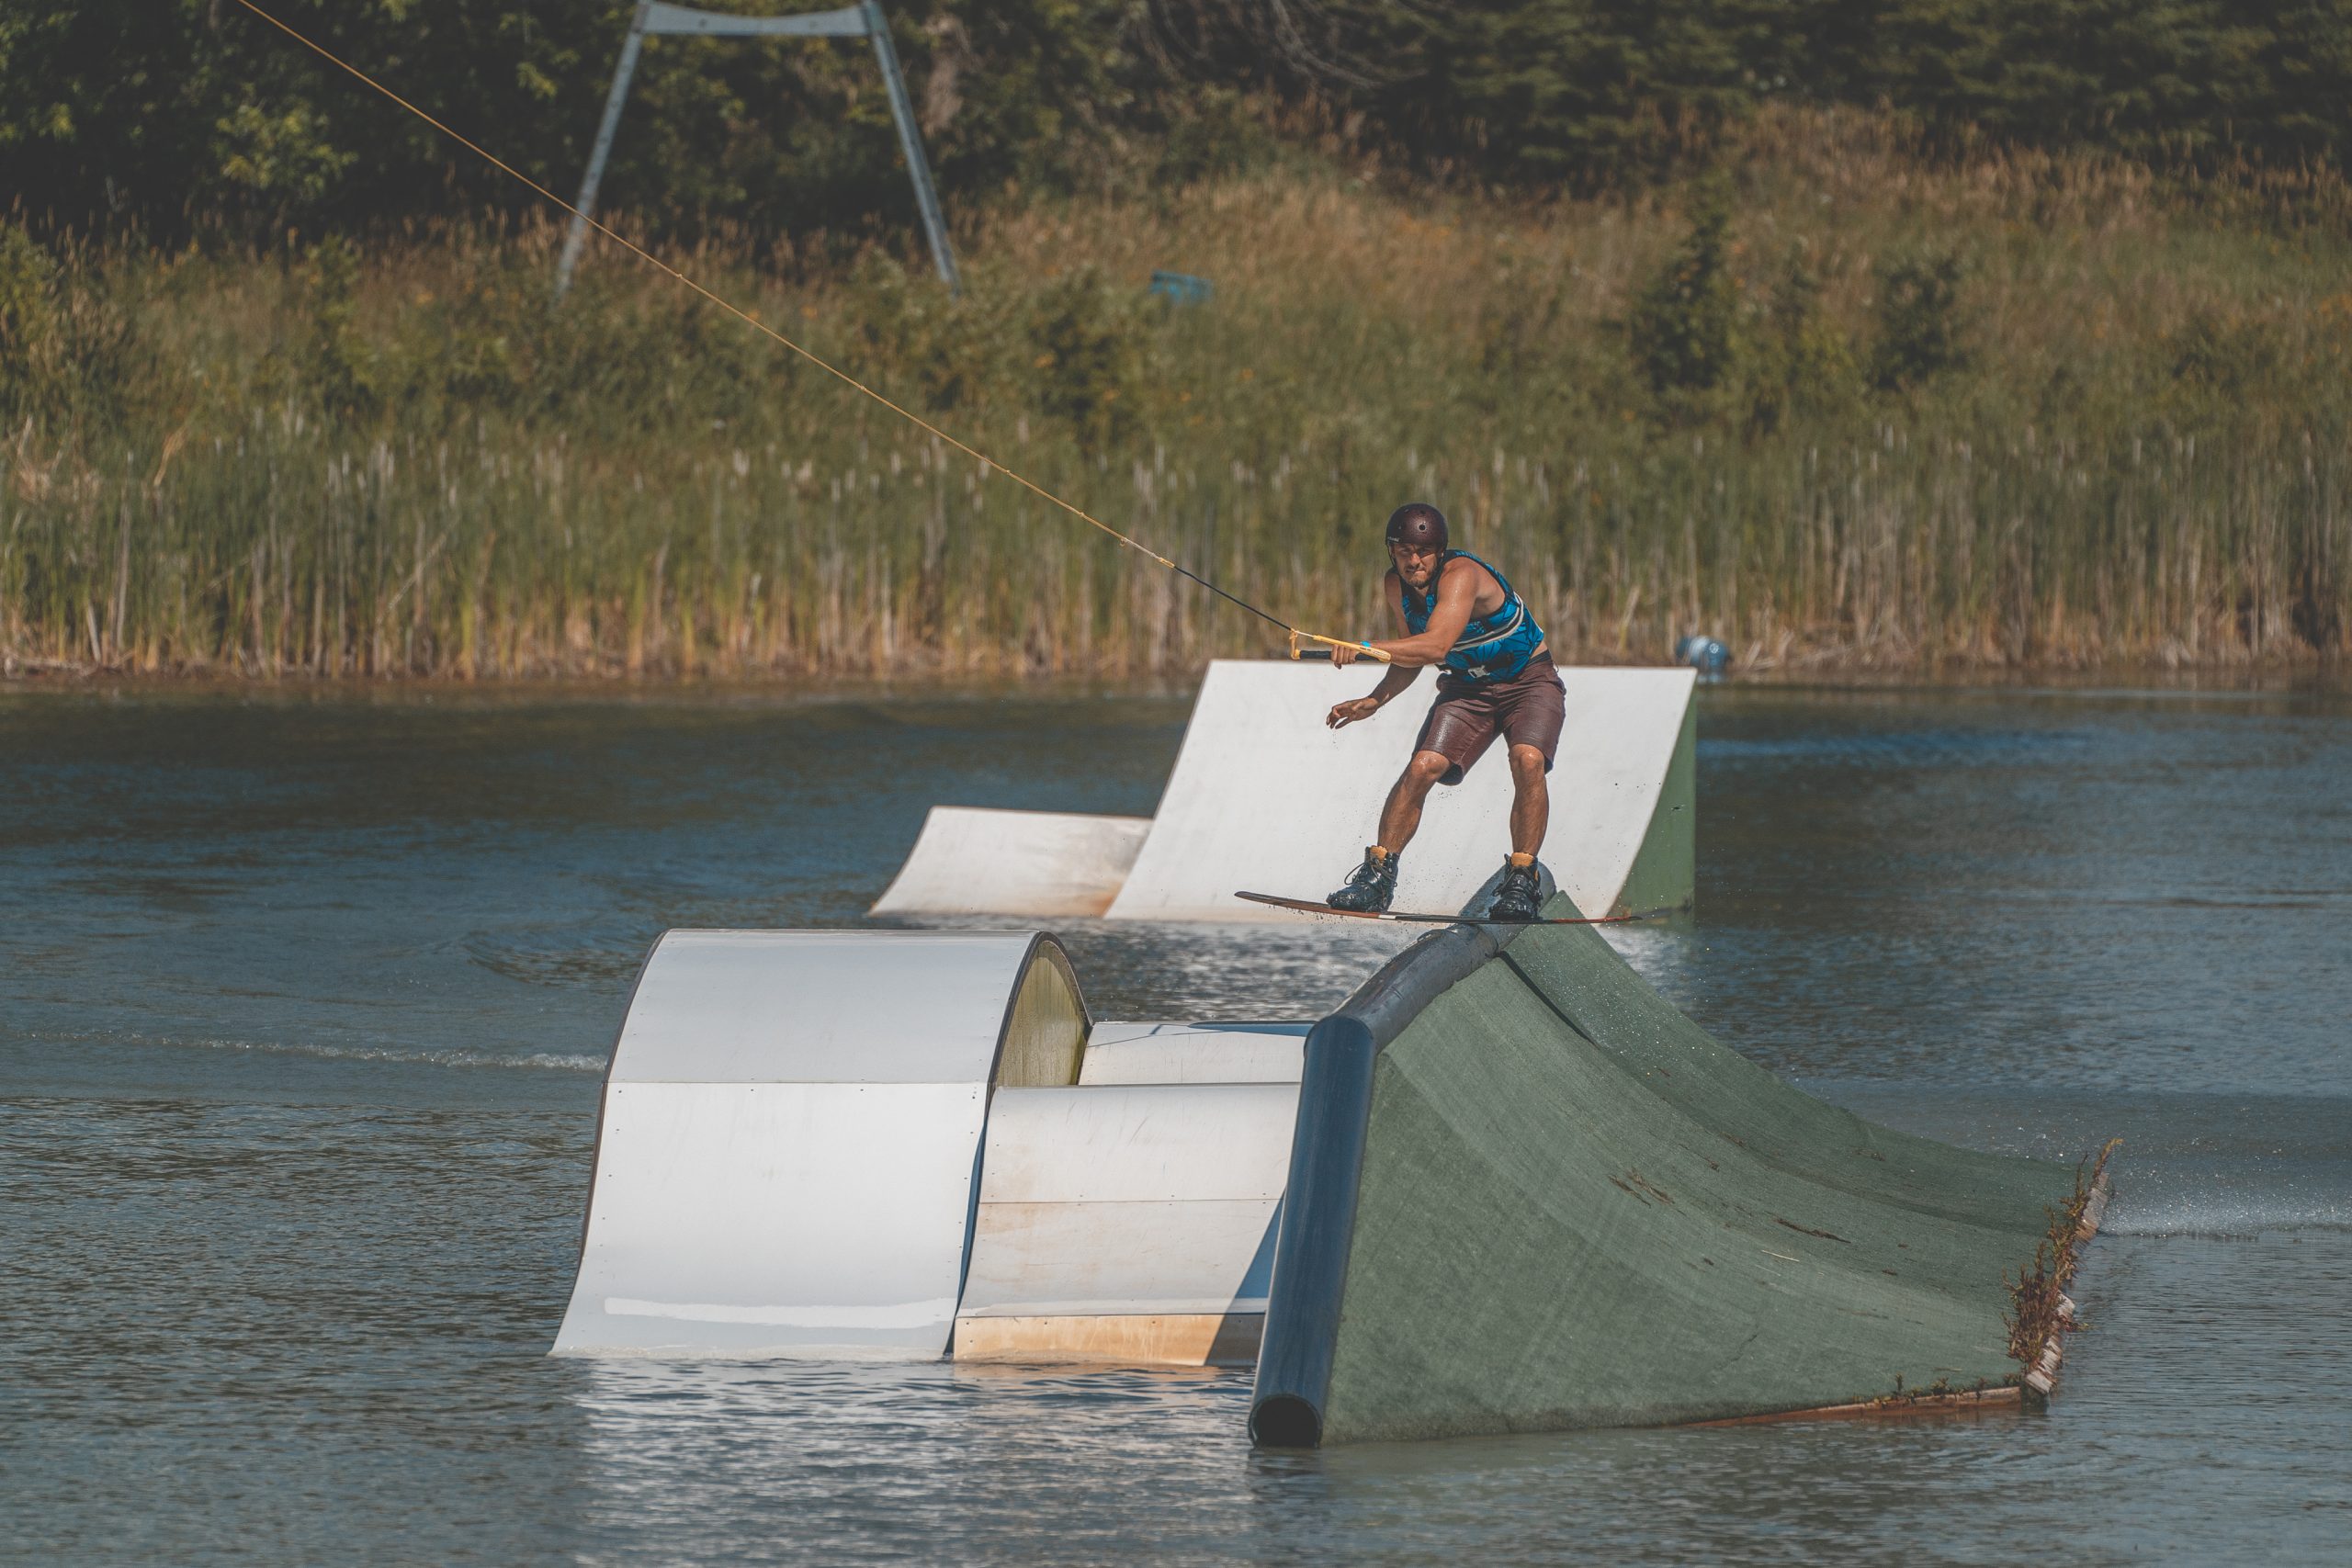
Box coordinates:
[870,807,1152,919]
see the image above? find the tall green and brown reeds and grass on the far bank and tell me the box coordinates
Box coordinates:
[0,110,2352,680]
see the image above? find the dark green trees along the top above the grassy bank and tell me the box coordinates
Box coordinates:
[0,0,2352,240]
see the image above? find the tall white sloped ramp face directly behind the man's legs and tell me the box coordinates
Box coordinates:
[1108,660,1698,921]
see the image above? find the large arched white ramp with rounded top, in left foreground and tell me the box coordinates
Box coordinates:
[555,931,1087,1359]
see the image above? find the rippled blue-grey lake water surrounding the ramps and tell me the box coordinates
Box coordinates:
[0,689,2352,1563]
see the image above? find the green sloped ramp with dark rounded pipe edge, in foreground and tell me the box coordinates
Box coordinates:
[1253,902,2075,1443]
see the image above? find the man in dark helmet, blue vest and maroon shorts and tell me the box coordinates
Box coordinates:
[1324,501,1566,919]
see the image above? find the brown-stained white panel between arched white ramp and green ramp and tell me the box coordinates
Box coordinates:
[955,1084,1298,1366]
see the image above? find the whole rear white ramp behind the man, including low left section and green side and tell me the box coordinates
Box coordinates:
[875,659,1698,921]
